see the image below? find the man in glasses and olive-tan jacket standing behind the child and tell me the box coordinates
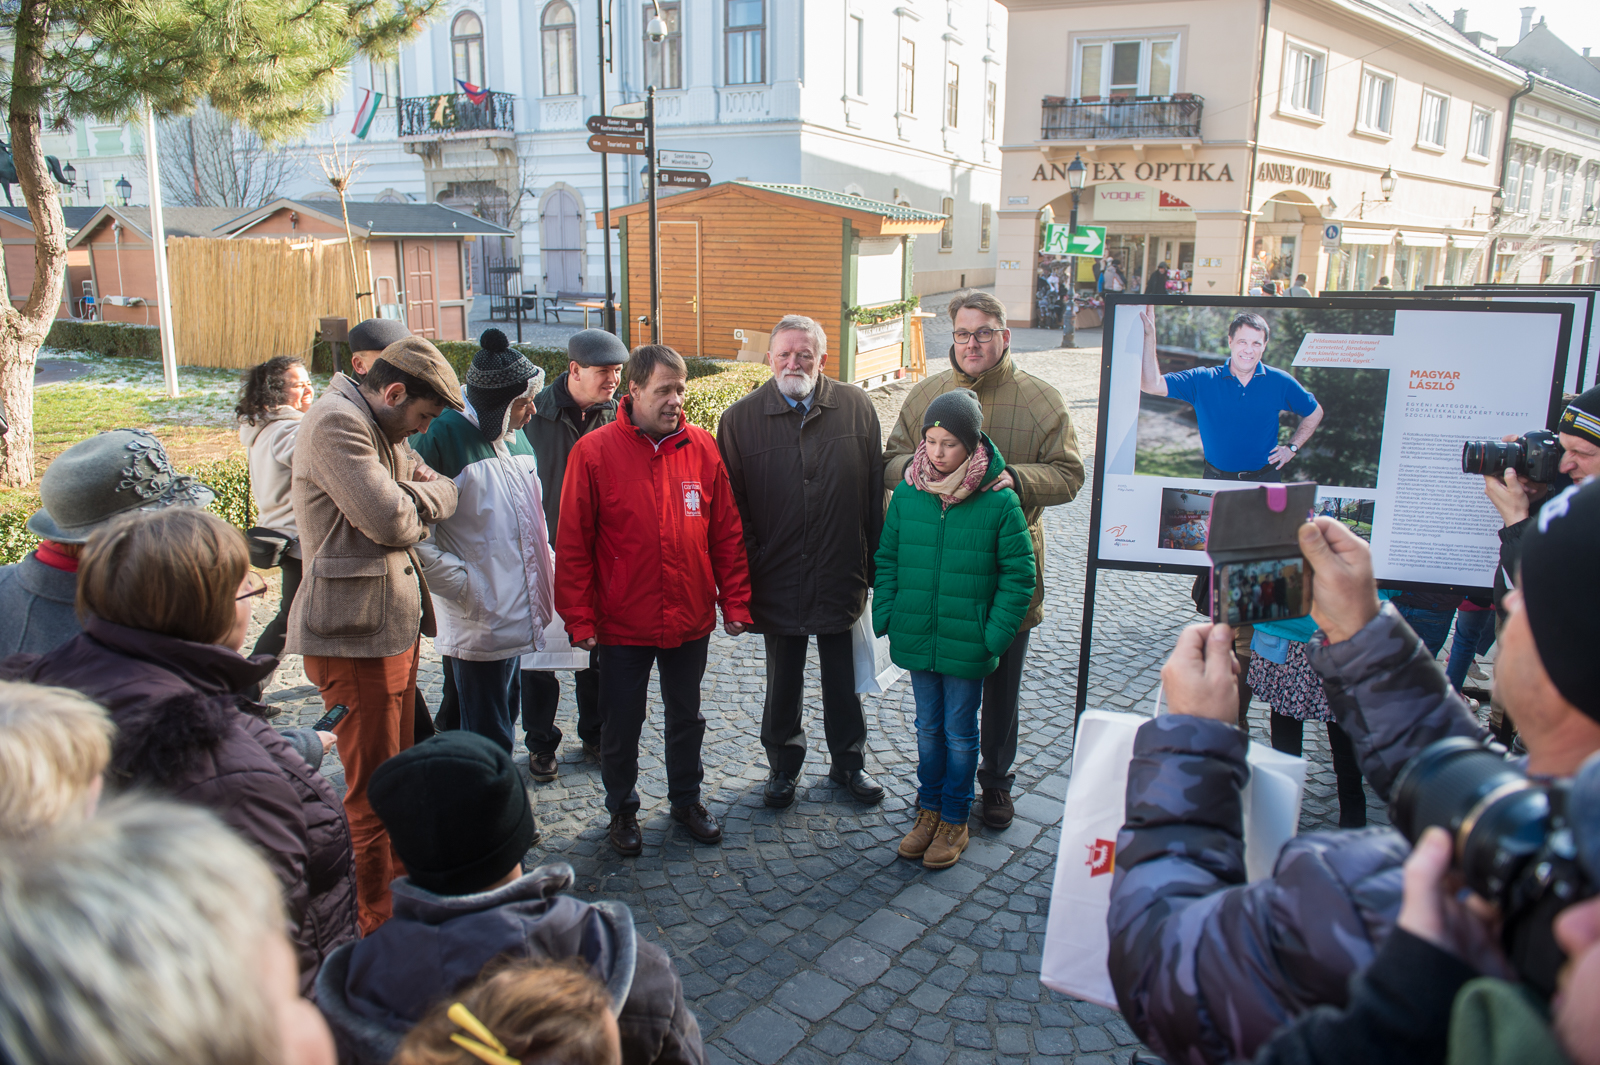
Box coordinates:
[883,293,1083,828]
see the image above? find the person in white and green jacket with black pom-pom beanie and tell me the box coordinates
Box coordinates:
[411,329,555,755]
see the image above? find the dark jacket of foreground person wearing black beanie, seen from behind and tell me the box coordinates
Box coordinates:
[317,862,706,1065]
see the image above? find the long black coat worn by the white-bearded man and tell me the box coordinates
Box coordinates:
[717,376,883,636]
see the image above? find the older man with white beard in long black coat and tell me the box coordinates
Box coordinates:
[717,315,883,808]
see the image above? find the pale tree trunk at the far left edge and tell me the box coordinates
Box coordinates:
[0,0,67,488]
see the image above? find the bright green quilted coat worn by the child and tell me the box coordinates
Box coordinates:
[872,435,1034,680]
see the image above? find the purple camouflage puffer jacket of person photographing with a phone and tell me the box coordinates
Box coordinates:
[1107,604,1486,1065]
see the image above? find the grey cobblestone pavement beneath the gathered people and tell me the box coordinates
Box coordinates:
[258,340,1384,1065]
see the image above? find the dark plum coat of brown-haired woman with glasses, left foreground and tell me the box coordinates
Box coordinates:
[0,617,357,993]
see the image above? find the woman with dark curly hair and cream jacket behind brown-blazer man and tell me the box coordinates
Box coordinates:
[234,355,317,656]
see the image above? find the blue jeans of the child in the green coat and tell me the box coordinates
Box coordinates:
[910,670,984,825]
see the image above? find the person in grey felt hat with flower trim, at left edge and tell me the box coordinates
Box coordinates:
[0,429,214,657]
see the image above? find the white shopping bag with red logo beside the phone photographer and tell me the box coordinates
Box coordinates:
[1038,696,1306,1009]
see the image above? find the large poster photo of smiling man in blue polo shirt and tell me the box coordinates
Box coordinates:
[1130,295,1395,488]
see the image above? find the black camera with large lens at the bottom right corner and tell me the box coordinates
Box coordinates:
[1389,736,1597,998]
